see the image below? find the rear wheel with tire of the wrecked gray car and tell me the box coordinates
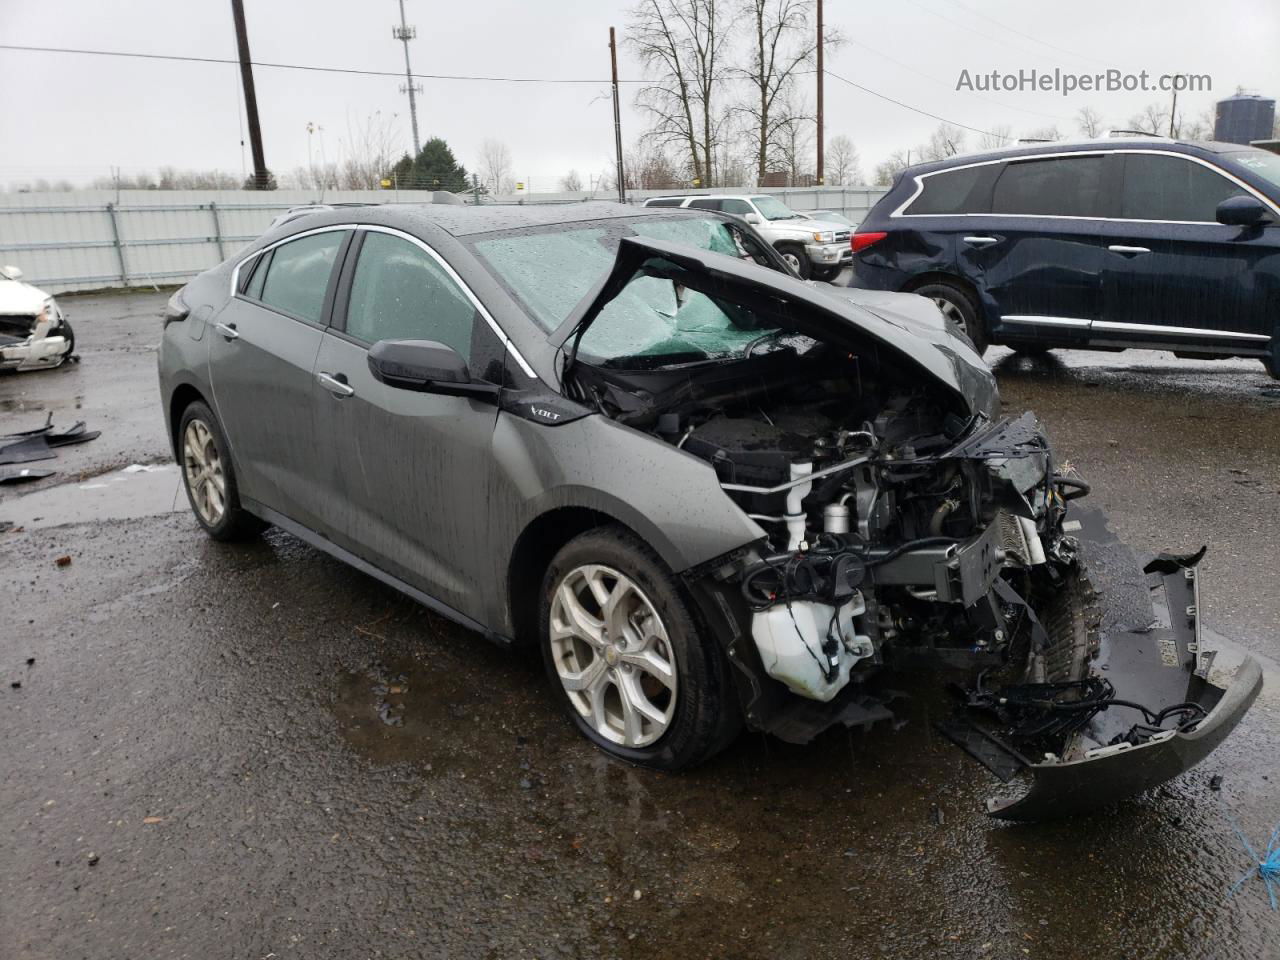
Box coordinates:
[178,401,268,541]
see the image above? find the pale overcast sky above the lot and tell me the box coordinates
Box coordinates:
[0,0,1280,189]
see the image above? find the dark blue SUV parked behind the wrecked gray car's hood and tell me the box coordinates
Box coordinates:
[852,138,1280,376]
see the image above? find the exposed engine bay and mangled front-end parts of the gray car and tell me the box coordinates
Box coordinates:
[568,300,1256,819]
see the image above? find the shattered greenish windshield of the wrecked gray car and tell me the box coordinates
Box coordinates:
[474,216,777,365]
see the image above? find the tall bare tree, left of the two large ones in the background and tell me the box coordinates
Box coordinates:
[627,0,728,186]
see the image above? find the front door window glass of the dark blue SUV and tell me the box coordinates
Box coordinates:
[1120,154,1245,223]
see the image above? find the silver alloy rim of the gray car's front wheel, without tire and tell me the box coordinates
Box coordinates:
[550,563,678,748]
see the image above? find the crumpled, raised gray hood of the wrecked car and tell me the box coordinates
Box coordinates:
[550,237,1000,419]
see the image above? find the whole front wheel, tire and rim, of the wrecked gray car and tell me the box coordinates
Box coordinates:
[539,527,741,771]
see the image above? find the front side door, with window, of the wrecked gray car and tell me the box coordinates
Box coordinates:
[315,228,506,618]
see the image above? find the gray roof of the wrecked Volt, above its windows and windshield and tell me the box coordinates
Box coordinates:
[275,200,672,237]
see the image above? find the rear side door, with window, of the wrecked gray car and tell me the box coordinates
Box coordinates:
[210,228,351,527]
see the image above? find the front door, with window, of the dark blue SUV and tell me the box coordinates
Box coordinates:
[1093,152,1280,352]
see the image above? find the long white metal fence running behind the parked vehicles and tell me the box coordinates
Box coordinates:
[0,187,884,293]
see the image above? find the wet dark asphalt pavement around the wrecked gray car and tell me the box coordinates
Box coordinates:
[0,294,1280,960]
